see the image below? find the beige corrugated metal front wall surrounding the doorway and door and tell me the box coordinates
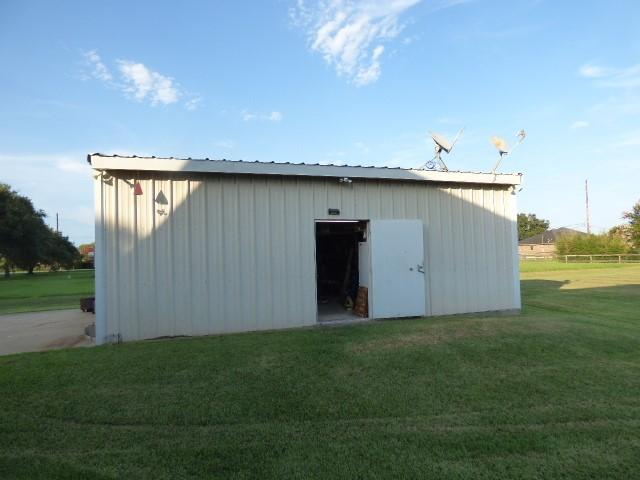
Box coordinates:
[96,172,520,342]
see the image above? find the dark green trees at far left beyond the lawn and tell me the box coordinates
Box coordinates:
[0,183,80,276]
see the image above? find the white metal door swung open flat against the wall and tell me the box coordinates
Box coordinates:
[369,220,425,318]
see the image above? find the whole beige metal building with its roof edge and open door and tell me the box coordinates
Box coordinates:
[88,154,521,343]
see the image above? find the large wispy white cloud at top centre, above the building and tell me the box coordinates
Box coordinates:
[290,0,421,86]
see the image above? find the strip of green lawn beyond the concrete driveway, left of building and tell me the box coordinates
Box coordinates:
[0,270,94,315]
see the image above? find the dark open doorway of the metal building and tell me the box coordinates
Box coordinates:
[316,220,368,322]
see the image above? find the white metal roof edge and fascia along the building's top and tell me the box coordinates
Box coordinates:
[87,153,522,185]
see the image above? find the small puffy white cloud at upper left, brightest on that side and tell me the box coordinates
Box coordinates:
[118,60,182,105]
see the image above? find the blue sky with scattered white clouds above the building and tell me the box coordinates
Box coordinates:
[0,0,640,243]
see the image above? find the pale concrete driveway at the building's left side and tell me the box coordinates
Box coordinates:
[0,309,95,355]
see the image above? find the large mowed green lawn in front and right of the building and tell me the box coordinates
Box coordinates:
[0,266,640,479]
